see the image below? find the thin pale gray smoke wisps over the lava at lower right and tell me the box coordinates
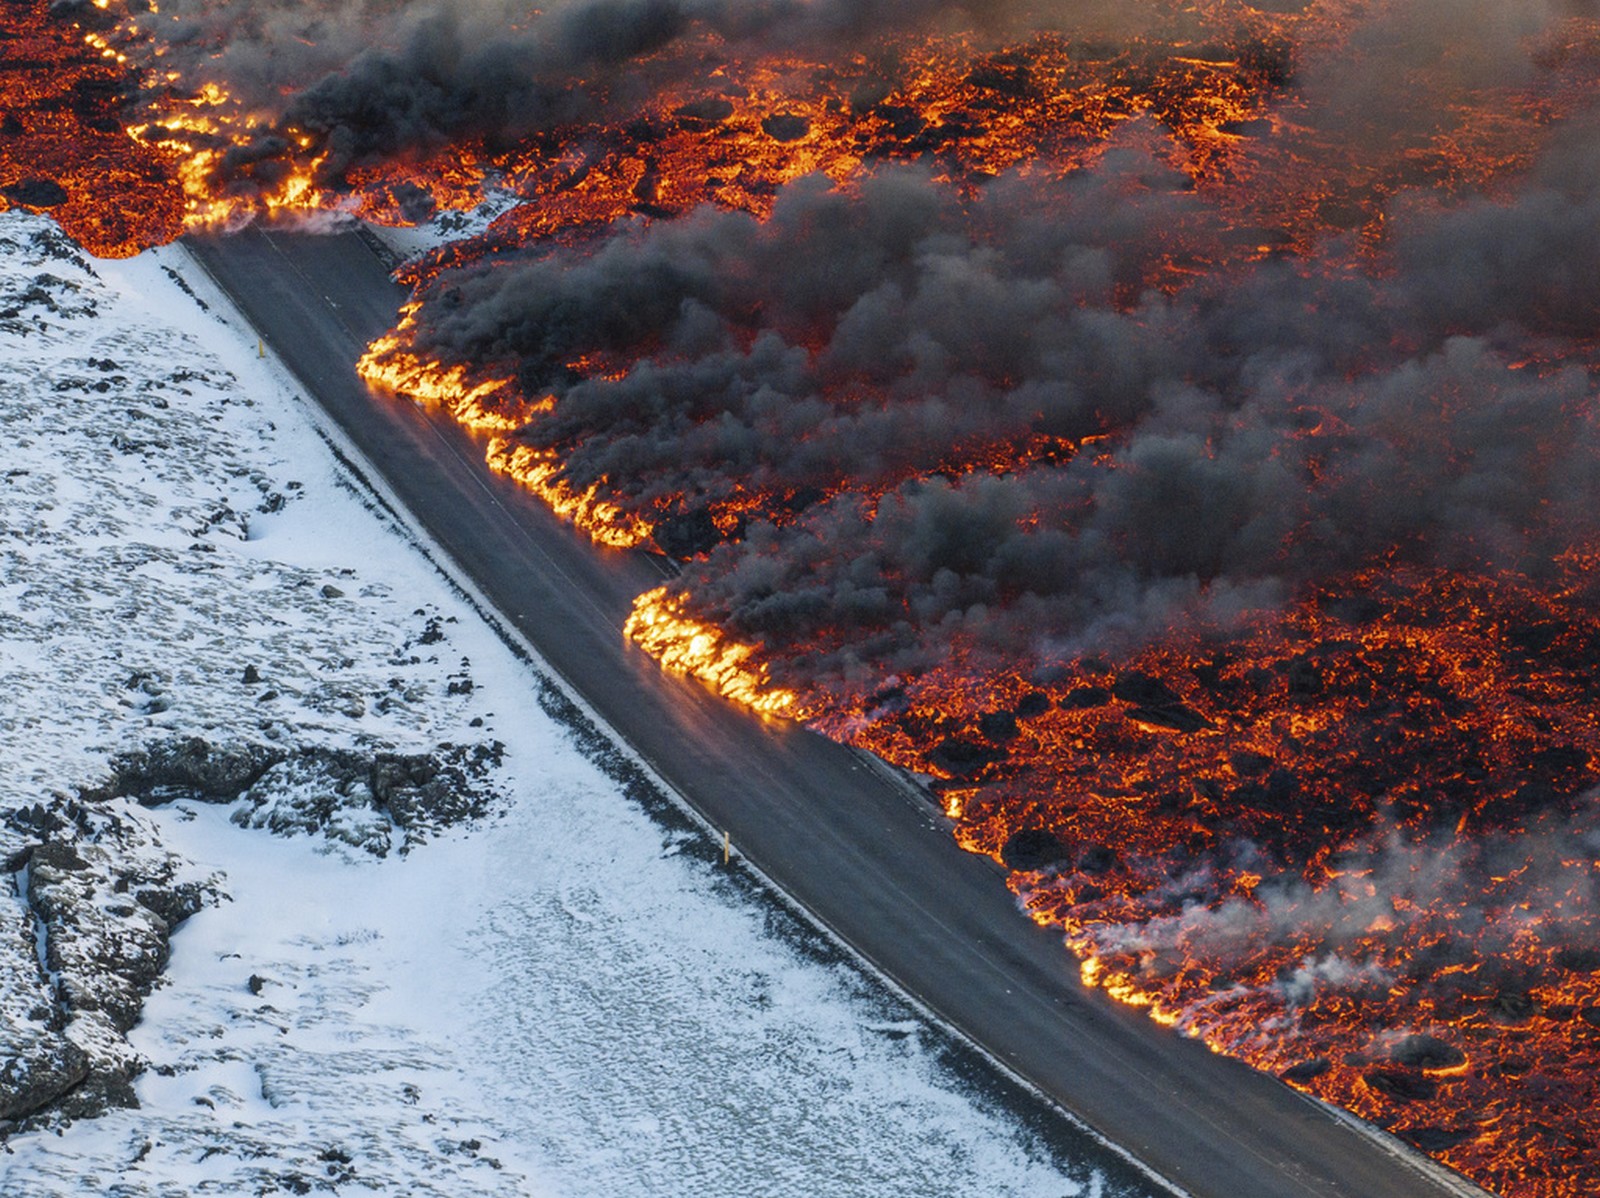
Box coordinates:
[1021,793,1600,1052]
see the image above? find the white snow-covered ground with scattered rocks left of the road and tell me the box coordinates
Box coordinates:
[0,213,1146,1198]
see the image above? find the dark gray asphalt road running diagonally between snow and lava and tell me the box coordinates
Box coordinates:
[190,229,1472,1198]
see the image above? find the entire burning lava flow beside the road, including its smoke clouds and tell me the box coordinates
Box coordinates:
[15,0,1600,1198]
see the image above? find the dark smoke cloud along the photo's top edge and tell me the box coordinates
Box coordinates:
[116,0,1139,190]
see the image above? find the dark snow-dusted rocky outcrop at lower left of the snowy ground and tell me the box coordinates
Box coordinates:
[0,736,502,1139]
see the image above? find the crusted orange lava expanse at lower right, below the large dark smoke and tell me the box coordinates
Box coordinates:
[853,573,1600,1193]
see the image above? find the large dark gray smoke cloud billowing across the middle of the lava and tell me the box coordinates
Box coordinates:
[396,131,1600,683]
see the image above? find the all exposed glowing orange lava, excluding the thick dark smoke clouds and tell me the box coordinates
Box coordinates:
[9,0,1600,1198]
